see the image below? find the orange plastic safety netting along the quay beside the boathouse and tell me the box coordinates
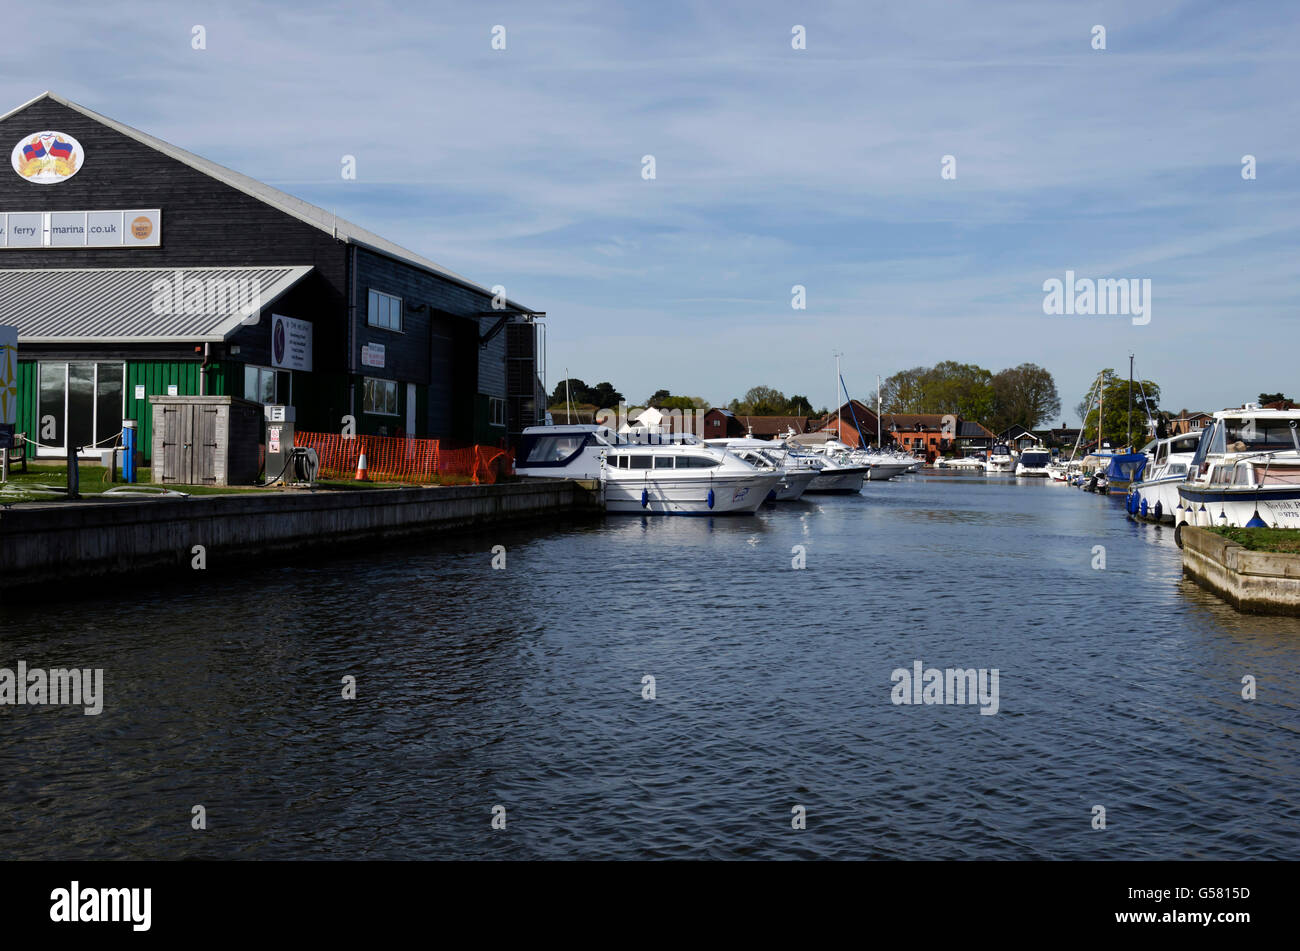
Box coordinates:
[294,433,515,486]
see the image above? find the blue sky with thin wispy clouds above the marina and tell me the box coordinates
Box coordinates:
[0,0,1300,420]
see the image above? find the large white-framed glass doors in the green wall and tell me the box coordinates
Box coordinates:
[30,362,126,456]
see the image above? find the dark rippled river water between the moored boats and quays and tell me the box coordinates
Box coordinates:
[0,473,1300,859]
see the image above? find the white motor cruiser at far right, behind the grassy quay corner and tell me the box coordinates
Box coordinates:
[1174,404,1300,529]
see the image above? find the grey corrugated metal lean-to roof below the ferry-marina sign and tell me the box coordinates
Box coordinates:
[0,266,312,344]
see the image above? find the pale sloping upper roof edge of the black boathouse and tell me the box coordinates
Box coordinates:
[0,91,538,313]
